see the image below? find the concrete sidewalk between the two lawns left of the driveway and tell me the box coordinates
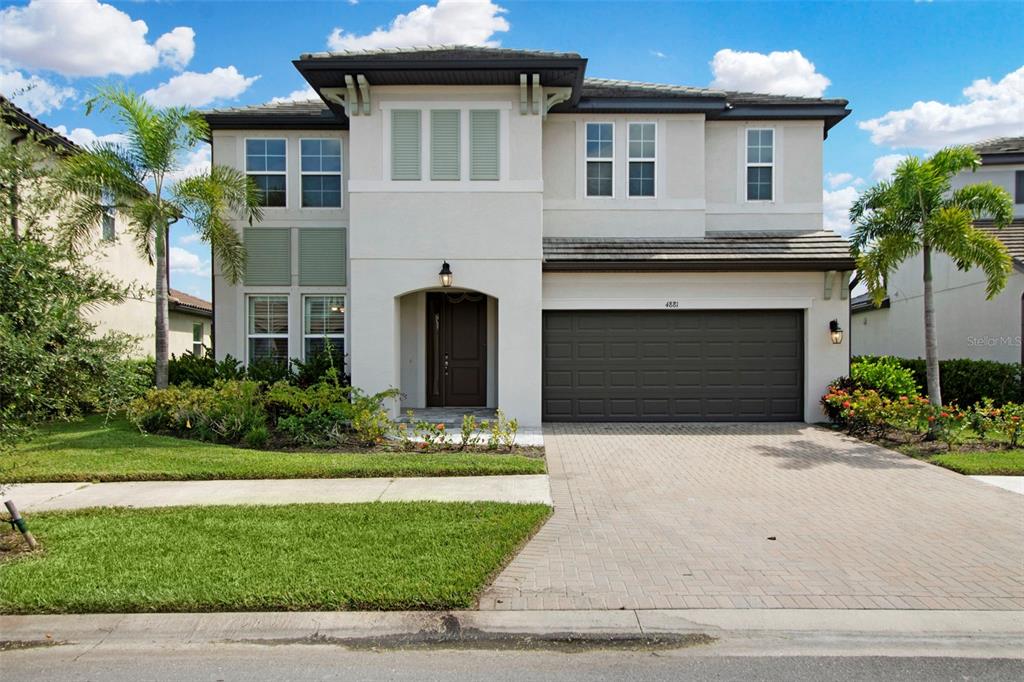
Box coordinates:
[4,474,551,512]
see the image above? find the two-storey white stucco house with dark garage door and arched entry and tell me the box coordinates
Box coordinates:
[206,47,854,426]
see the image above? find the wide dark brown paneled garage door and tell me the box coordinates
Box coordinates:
[543,310,804,422]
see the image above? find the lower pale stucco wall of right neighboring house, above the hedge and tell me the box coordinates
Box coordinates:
[850,249,1024,363]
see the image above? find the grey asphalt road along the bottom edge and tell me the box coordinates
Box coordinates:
[0,644,1024,682]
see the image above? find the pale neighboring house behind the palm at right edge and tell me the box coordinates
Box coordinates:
[850,137,1024,363]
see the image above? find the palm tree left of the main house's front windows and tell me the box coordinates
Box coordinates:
[58,87,262,388]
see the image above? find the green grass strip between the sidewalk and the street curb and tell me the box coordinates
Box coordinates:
[0,502,550,613]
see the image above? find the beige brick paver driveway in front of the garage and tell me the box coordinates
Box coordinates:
[480,424,1024,609]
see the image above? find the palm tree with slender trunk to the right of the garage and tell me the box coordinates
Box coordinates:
[850,146,1013,406]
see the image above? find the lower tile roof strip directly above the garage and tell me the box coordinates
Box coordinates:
[544,231,854,270]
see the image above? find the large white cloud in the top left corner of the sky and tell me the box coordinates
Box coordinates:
[0,0,195,76]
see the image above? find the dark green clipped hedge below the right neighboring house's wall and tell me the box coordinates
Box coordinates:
[851,357,1024,407]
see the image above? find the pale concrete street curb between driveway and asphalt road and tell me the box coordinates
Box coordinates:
[0,609,1024,649]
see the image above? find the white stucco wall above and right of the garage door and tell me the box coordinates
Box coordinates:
[543,272,850,422]
